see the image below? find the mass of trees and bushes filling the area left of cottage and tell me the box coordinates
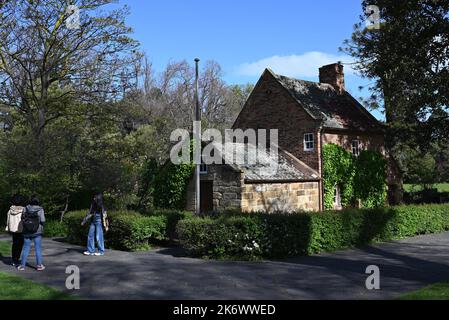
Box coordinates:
[0,0,248,220]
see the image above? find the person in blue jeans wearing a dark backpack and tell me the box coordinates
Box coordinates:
[17,196,45,271]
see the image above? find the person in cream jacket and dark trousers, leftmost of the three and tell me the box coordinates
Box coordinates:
[5,194,25,267]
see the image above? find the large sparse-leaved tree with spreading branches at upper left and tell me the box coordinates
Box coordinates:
[0,0,138,168]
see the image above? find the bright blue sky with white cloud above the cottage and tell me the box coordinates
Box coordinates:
[119,0,381,117]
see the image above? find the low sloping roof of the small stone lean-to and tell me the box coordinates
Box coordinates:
[209,142,320,182]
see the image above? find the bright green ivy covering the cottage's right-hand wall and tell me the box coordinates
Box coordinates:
[323,144,386,209]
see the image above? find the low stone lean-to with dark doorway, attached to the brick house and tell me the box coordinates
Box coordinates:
[187,143,320,212]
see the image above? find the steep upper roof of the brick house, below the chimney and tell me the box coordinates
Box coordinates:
[265,69,383,131]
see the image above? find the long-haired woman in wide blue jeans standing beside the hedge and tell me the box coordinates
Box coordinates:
[81,193,109,256]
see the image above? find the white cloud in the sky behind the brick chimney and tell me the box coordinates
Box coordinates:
[237,51,354,78]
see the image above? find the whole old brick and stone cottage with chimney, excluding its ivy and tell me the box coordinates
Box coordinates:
[188,63,384,211]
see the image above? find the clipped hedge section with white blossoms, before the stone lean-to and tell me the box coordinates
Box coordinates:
[178,213,310,260]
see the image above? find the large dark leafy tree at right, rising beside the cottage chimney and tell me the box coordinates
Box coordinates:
[343,0,449,201]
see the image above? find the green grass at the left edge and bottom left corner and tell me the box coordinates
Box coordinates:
[0,241,77,300]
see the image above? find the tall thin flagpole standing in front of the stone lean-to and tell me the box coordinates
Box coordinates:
[194,58,201,215]
